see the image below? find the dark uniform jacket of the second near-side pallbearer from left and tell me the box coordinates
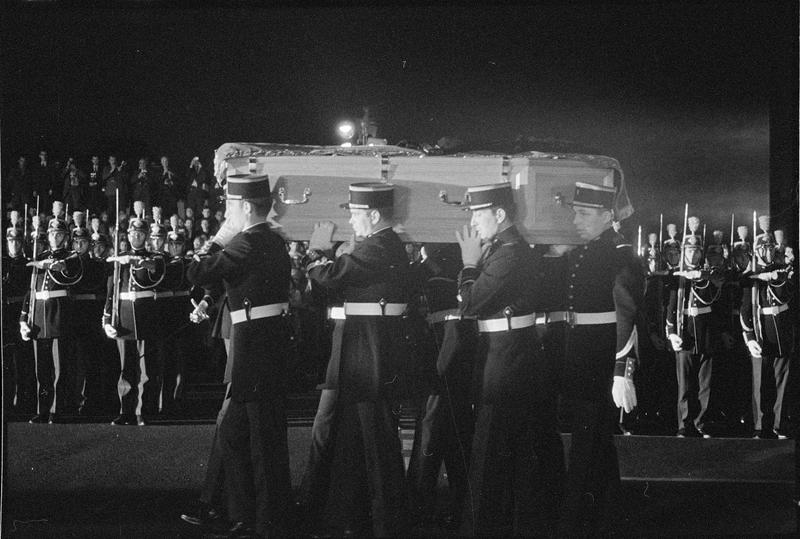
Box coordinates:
[308,228,409,402]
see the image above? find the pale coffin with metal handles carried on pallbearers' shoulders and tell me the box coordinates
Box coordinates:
[215,143,622,244]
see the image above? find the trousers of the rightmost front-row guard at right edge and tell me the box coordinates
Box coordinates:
[751,354,789,430]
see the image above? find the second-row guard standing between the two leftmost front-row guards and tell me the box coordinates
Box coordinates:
[71,228,109,415]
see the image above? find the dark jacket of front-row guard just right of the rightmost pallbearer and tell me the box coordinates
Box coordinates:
[666,271,723,354]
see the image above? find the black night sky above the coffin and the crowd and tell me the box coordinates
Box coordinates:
[2,1,797,238]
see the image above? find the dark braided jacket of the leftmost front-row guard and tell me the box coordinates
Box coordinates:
[19,249,83,339]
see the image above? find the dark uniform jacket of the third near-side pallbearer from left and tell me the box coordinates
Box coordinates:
[458,226,556,405]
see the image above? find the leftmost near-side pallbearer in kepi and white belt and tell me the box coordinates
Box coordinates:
[187,176,291,537]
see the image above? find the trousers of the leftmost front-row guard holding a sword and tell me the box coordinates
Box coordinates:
[33,338,73,414]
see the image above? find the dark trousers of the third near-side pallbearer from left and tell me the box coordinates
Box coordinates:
[461,402,564,535]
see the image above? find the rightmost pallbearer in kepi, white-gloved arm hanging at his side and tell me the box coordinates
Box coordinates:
[559,182,644,535]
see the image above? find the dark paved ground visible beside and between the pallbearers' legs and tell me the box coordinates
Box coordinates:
[3,423,797,537]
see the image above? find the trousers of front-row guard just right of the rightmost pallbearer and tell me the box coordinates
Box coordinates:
[675,351,713,429]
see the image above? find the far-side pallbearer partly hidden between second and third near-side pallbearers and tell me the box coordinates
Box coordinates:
[408,244,478,529]
